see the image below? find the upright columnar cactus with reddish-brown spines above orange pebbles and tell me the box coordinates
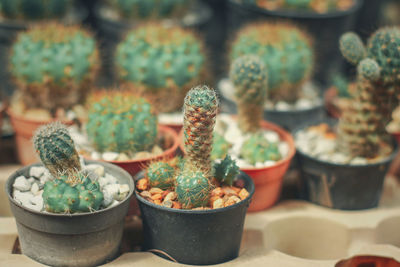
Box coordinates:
[183,85,219,178]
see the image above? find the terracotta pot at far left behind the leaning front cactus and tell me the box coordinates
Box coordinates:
[7,109,73,165]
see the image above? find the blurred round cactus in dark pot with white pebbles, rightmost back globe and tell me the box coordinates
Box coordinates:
[219,23,324,130]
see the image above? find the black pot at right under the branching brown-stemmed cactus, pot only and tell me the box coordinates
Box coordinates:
[293,121,398,210]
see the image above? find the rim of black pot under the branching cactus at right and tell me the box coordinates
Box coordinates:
[292,119,399,168]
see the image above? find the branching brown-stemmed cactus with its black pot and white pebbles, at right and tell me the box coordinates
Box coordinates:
[296,27,400,209]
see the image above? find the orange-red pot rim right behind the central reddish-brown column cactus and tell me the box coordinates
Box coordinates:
[179,115,296,172]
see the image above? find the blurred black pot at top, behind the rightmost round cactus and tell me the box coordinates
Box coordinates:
[228,0,362,85]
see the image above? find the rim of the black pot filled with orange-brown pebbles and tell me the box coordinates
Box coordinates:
[134,171,255,215]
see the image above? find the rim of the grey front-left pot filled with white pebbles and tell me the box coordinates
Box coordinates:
[5,160,136,217]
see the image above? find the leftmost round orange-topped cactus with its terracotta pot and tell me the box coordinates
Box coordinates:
[8,23,99,165]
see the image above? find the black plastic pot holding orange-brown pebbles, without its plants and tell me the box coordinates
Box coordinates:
[135,172,254,265]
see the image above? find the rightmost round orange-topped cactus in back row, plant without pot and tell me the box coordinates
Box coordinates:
[230,22,314,102]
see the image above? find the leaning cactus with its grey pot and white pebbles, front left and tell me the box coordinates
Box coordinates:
[6,123,134,266]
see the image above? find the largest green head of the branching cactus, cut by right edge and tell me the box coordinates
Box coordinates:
[367,27,400,83]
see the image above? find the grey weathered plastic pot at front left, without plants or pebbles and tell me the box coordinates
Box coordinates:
[6,161,135,266]
